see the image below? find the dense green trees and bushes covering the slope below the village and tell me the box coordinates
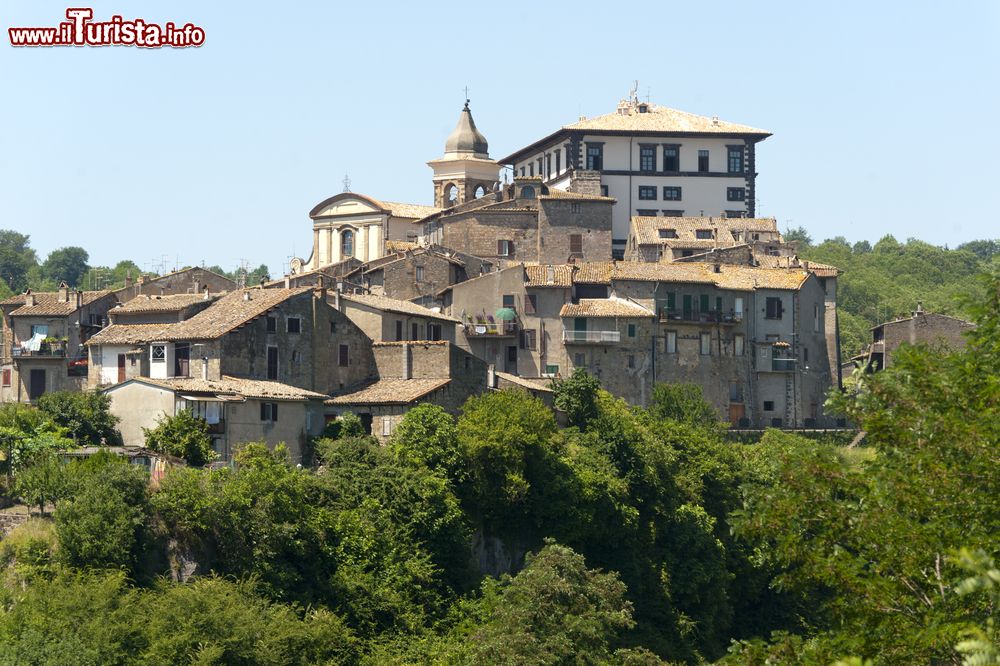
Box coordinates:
[0,268,1000,665]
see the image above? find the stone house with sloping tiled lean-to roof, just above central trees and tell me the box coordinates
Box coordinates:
[326,340,487,442]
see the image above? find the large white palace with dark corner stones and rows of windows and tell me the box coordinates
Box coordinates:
[500,97,771,258]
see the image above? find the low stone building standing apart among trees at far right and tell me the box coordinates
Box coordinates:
[851,303,976,372]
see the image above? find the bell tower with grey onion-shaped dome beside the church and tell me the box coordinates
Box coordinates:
[427,100,500,208]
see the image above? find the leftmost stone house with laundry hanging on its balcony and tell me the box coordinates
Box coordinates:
[0,283,118,402]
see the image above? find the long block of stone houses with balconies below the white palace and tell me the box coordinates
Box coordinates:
[450,262,837,427]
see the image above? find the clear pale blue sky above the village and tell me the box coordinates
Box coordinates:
[0,0,1000,275]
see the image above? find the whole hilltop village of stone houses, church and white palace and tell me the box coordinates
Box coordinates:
[0,97,868,459]
